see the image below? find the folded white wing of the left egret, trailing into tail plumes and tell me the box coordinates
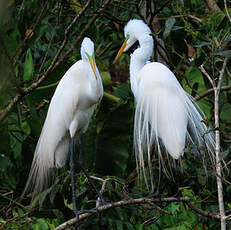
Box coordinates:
[24,62,83,198]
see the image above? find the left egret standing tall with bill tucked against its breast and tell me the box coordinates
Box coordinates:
[24,37,103,225]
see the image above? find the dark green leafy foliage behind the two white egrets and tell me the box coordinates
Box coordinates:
[0,0,231,230]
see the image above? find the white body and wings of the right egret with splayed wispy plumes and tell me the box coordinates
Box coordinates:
[134,63,214,180]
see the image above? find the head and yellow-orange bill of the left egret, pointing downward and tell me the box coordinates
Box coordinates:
[80,37,97,79]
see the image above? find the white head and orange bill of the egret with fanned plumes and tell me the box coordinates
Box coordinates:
[114,19,151,62]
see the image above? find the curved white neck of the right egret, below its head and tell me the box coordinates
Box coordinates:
[130,33,153,96]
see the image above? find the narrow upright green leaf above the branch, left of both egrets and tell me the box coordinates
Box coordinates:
[23,49,34,86]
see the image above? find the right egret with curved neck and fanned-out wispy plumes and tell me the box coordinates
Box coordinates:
[115,19,214,189]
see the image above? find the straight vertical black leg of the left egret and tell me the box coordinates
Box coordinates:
[70,137,79,229]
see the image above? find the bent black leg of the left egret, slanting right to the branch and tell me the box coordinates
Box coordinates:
[79,134,105,203]
